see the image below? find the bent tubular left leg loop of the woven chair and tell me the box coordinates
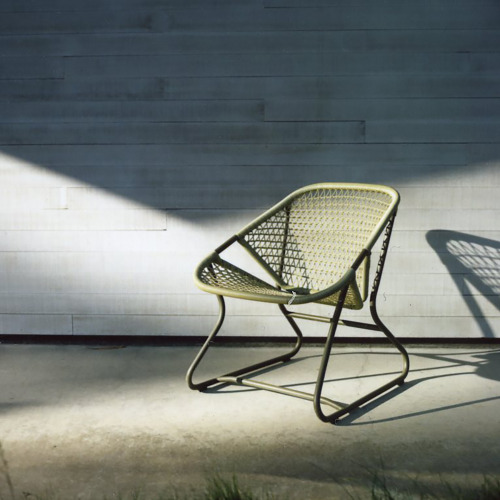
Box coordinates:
[186,295,303,391]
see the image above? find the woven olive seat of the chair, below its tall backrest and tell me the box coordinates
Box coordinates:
[197,255,363,309]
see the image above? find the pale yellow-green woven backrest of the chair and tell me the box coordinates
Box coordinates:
[238,183,399,300]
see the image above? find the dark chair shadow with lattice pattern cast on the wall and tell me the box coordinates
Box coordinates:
[426,229,500,338]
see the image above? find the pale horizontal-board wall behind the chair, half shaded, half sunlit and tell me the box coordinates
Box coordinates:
[0,0,500,339]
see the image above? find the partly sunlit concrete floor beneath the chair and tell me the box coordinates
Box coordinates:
[0,345,500,500]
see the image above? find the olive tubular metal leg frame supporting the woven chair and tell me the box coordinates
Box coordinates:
[186,186,410,424]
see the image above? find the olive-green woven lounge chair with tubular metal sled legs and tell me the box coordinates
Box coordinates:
[186,183,409,423]
